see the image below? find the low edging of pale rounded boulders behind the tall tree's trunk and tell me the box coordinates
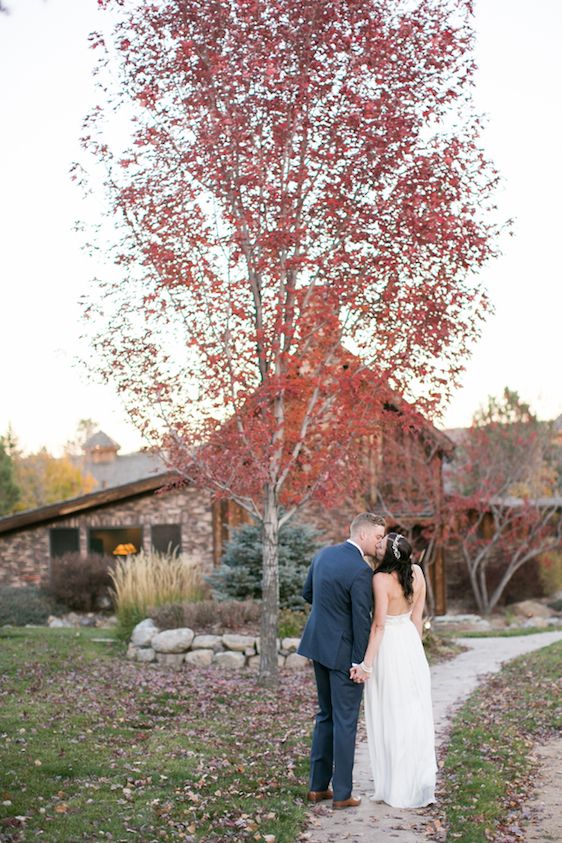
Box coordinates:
[127,619,310,670]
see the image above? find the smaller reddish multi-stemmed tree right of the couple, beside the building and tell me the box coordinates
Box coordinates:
[449,388,562,615]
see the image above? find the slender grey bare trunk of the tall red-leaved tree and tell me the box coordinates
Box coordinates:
[259,486,279,687]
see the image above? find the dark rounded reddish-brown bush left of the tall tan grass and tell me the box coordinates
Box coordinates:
[43,553,115,612]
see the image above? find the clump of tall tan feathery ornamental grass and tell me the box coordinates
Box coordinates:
[111,551,206,638]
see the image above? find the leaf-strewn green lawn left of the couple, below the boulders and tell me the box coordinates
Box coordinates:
[0,628,315,843]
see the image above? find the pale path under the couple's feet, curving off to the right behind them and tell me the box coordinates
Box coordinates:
[305,631,562,843]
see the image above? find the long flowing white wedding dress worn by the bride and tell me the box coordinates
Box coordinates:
[364,612,437,808]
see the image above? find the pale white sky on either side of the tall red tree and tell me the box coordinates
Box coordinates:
[0,0,562,453]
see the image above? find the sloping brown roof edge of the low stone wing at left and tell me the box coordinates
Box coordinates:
[0,471,179,534]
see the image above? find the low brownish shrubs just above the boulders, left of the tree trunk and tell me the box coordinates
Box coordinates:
[150,600,261,632]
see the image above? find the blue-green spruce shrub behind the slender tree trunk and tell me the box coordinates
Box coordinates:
[207,524,319,610]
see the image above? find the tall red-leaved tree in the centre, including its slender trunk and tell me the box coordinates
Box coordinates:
[77,0,497,680]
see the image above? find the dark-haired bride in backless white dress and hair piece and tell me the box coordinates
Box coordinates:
[352,533,437,808]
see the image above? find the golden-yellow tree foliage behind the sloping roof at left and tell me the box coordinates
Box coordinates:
[14,448,95,512]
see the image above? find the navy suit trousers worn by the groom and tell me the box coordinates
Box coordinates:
[310,661,363,801]
